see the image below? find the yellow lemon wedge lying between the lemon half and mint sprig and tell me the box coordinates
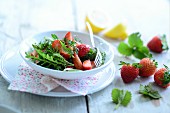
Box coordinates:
[104,23,128,40]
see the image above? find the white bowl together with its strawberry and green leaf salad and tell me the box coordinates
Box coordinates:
[19,31,114,79]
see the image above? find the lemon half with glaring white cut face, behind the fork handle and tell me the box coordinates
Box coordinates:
[85,10,108,33]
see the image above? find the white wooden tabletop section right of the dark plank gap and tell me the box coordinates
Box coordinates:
[77,0,170,113]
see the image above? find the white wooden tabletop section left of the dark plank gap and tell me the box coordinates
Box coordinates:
[0,0,87,113]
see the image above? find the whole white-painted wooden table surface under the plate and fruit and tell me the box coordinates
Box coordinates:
[0,0,170,113]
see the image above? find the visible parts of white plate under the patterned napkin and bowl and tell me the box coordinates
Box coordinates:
[0,47,115,97]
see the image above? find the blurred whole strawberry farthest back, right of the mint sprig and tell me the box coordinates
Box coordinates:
[147,35,169,53]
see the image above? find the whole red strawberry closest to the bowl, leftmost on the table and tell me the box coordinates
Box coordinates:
[120,61,140,83]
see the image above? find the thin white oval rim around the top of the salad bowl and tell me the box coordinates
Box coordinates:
[19,30,114,74]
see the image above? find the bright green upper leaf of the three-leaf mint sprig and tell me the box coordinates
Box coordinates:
[128,32,143,48]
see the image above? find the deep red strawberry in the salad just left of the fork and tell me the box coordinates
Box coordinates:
[77,44,90,57]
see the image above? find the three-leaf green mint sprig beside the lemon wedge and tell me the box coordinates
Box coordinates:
[118,32,150,59]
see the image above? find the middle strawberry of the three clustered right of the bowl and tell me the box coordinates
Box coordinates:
[139,58,157,77]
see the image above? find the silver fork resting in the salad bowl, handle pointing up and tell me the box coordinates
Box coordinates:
[86,22,102,67]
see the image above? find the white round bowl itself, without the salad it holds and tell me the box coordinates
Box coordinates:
[19,31,114,79]
